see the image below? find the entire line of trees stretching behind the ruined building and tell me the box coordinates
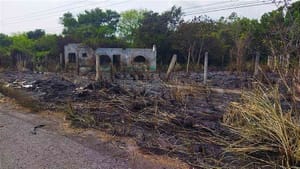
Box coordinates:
[0,2,300,70]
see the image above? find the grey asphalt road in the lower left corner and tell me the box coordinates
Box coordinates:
[0,103,130,169]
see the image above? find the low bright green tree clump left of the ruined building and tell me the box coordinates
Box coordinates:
[0,31,61,68]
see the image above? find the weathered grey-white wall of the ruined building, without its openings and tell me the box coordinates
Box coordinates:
[64,43,157,71]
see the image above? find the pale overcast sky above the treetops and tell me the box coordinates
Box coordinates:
[0,0,296,34]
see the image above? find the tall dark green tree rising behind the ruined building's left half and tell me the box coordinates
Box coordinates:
[60,8,120,47]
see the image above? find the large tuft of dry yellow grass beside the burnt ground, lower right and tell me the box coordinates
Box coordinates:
[223,87,300,168]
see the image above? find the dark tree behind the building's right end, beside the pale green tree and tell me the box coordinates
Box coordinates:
[134,6,182,64]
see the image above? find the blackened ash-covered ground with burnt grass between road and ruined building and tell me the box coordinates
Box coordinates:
[0,71,252,167]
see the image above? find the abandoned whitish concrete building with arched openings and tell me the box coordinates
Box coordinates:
[64,43,157,72]
